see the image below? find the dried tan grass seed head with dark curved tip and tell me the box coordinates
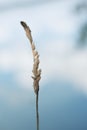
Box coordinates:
[21,21,41,94]
